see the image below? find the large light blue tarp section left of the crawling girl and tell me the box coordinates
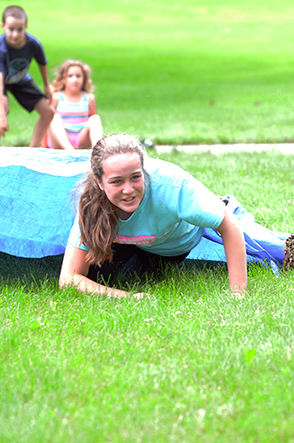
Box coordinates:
[0,148,91,258]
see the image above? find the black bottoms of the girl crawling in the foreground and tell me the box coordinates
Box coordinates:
[87,243,189,284]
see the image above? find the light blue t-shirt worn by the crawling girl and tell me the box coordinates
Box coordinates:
[69,157,225,256]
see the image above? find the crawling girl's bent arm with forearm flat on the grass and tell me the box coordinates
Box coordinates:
[59,244,141,298]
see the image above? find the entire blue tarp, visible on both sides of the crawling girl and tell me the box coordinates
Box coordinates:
[0,147,290,271]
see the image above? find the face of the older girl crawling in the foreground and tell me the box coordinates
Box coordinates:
[99,152,145,220]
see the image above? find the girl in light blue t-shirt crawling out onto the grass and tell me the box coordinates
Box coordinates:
[60,134,247,297]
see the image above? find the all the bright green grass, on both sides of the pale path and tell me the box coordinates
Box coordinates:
[0,0,294,443]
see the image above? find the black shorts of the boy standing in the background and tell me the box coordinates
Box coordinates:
[4,80,46,112]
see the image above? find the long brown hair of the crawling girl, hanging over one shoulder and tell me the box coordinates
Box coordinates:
[79,134,146,266]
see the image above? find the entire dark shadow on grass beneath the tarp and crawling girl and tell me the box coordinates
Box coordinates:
[0,252,263,295]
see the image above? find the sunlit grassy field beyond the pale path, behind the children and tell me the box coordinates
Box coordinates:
[1,0,294,146]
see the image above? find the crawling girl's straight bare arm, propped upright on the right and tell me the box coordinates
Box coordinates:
[216,210,247,293]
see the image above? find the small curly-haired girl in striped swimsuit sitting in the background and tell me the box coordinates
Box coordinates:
[42,60,102,150]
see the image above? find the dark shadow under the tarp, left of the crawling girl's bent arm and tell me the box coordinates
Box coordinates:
[0,252,63,284]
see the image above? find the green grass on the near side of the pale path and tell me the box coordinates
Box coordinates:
[0,152,294,443]
